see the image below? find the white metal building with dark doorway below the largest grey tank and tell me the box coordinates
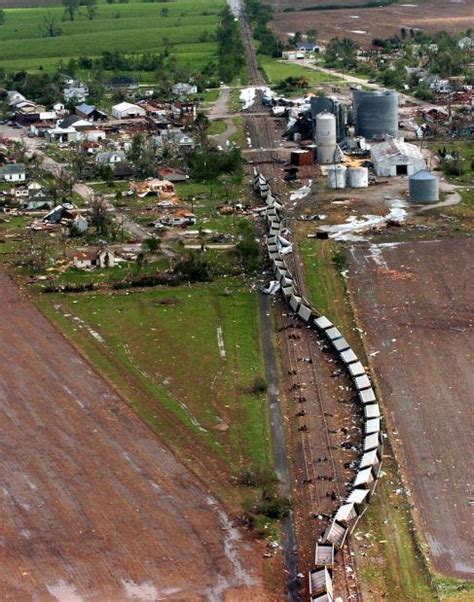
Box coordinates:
[370,137,426,176]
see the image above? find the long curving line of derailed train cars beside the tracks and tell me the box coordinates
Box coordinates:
[254,170,383,602]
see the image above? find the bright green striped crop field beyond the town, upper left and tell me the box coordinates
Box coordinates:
[0,0,225,71]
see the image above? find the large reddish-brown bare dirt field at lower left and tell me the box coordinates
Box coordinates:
[0,272,275,602]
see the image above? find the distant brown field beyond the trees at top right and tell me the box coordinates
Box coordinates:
[273,0,474,47]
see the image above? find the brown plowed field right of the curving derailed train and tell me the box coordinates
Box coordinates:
[348,239,474,579]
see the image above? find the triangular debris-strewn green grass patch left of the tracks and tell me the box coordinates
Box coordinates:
[39,279,270,496]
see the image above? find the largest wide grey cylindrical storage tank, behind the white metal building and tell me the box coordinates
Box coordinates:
[352,90,398,138]
